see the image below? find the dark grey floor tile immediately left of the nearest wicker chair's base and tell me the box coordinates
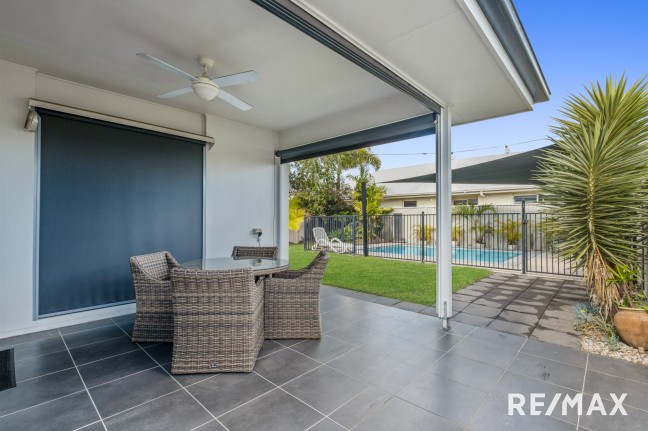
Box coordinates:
[79,350,157,387]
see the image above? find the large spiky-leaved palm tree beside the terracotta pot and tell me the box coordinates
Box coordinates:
[537,77,648,319]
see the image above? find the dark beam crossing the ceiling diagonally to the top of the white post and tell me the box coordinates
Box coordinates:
[252,0,441,113]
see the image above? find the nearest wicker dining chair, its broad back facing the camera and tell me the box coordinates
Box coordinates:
[171,268,263,374]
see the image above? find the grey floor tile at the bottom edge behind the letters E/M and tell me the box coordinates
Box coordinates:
[468,395,575,431]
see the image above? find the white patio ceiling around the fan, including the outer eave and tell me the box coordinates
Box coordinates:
[0,0,538,148]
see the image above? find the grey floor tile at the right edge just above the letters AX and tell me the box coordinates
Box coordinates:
[585,369,648,411]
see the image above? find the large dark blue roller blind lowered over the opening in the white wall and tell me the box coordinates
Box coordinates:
[38,110,204,315]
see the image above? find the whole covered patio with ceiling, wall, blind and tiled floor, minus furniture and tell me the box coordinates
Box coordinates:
[8,0,648,431]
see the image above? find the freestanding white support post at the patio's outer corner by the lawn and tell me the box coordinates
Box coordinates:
[436,108,452,329]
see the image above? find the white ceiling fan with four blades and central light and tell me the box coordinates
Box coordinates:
[137,53,259,111]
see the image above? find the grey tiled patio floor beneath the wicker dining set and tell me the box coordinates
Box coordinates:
[0,287,648,431]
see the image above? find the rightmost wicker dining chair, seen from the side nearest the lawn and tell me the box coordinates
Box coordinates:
[264,251,329,339]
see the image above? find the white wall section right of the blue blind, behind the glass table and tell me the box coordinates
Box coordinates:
[206,116,280,257]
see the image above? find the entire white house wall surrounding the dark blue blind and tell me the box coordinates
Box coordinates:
[0,61,287,338]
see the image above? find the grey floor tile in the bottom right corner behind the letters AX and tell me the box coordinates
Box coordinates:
[580,394,648,431]
